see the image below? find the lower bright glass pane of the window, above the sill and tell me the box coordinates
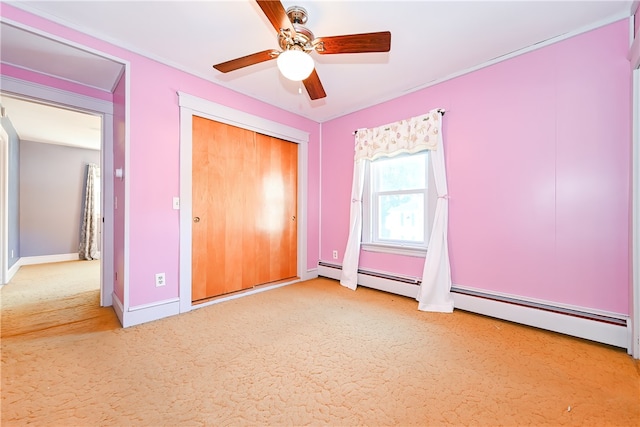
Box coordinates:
[377,194,424,243]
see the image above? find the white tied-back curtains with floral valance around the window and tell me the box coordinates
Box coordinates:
[340,109,453,312]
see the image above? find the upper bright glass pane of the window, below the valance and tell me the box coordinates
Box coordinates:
[371,151,427,191]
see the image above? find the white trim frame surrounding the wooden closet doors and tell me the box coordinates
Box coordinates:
[178,92,310,313]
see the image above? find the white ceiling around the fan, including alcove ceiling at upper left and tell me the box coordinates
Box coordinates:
[0,0,633,149]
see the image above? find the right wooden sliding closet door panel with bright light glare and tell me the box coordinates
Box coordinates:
[255,134,298,284]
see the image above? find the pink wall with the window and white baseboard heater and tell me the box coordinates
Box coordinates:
[320,20,631,314]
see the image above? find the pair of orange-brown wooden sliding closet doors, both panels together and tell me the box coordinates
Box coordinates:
[192,116,298,303]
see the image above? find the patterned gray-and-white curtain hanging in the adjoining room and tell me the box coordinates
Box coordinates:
[78,163,99,260]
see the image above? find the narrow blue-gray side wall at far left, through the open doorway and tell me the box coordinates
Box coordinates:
[0,113,20,268]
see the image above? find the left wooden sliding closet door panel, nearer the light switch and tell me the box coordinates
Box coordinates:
[192,116,257,302]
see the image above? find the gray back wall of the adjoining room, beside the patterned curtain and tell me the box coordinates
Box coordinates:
[20,141,100,257]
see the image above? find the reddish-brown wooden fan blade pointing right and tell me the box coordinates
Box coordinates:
[313,31,391,55]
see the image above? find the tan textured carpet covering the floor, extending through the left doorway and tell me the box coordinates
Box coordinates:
[1,262,640,426]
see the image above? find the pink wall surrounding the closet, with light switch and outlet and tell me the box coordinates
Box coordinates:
[1,4,320,306]
